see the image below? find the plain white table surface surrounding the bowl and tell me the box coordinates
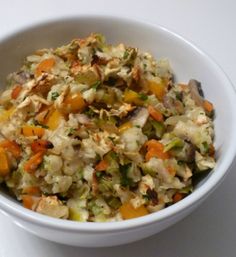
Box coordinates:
[0,0,236,257]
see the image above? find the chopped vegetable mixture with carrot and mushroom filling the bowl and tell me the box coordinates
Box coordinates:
[0,34,215,222]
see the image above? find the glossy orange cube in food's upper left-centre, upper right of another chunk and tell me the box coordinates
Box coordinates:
[63,92,85,113]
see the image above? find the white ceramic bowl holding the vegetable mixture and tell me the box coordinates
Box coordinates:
[0,16,236,247]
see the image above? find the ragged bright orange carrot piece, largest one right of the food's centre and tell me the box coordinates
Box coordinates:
[145,139,170,161]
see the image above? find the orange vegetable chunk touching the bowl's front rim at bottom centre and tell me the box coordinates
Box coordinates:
[120,202,148,220]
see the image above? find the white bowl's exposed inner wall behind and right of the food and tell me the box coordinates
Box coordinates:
[0,16,236,224]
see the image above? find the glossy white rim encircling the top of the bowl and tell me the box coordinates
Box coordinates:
[0,14,236,233]
